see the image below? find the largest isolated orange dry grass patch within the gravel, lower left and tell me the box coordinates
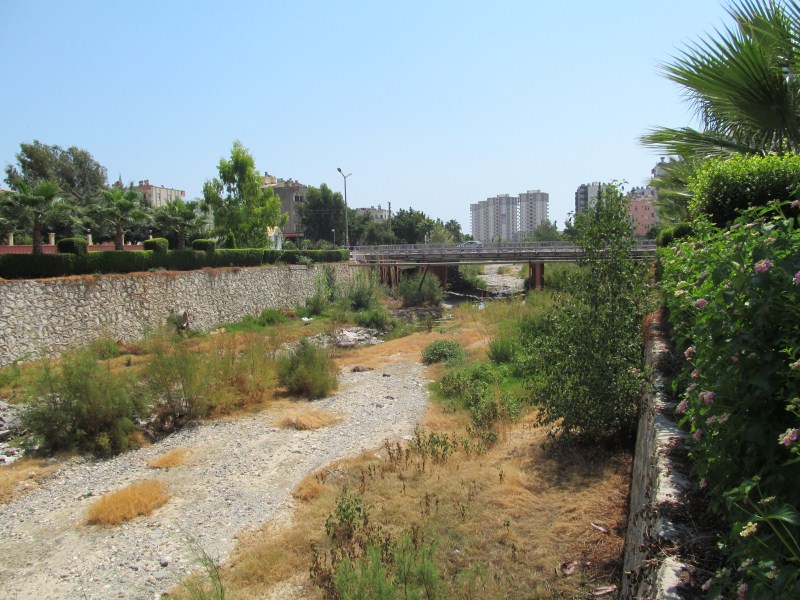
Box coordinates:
[86,479,170,527]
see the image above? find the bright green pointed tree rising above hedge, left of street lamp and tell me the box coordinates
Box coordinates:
[203,140,286,248]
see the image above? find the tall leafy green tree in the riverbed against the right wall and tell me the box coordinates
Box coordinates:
[524,186,644,443]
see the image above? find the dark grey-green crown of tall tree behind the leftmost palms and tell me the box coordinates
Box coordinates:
[5,140,107,205]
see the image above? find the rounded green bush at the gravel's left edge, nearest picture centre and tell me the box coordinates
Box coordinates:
[278,338,339,399]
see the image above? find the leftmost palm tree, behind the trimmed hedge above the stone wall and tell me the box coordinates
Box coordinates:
[0,181,69,254]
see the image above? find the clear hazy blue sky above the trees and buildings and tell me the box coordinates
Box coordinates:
[0,0,730,232]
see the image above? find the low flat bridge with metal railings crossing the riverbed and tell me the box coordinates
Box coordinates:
[350,240,656,290]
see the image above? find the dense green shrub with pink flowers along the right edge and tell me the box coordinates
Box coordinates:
[660,202,800,598]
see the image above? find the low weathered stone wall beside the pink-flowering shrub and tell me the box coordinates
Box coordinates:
[619,330,695,600]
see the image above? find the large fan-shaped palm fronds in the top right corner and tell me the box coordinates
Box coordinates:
[641,0,800,159]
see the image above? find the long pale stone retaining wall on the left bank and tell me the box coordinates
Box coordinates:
[0,265,354,366]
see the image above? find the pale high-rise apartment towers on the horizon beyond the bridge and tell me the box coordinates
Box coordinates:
[469,190,550,244]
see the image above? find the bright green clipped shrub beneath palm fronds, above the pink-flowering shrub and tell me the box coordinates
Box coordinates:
[688,154,800,226]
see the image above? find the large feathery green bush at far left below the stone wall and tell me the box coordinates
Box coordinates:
[23,348,145,455]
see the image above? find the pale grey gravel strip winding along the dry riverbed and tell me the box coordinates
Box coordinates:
[0,361,428,600]
